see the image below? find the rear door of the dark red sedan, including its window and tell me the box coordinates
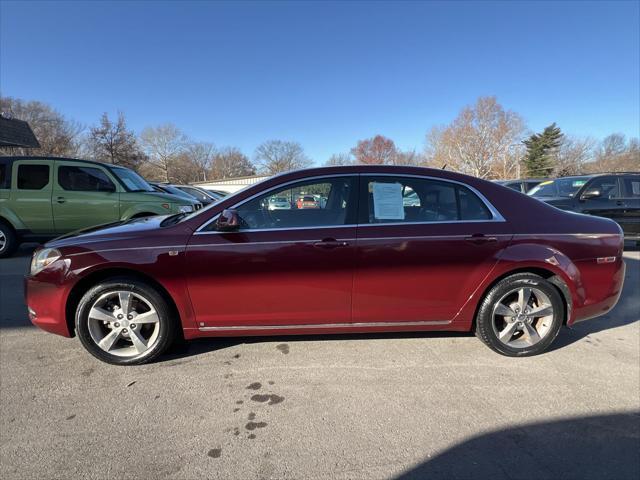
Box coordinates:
[353,175,512,327]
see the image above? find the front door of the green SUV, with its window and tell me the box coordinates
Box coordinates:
[53,161,120,233]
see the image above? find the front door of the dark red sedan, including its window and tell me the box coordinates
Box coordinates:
[186,175,358,331]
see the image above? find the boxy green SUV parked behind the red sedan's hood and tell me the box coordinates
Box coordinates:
[0,157,201,258]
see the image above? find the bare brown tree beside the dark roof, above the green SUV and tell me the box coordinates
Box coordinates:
[0,97,84,157]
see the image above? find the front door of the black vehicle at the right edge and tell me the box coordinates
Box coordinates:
[577,175,625,224]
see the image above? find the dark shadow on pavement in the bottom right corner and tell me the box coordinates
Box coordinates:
[397,412,640,480]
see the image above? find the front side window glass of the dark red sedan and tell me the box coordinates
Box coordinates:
[225,177,355,230]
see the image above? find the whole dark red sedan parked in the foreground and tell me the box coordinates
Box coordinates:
[26,166,625,365]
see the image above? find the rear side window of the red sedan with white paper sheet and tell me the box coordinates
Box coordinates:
[367,177,493,223]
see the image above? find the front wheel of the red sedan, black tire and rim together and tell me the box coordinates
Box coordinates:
[76,278,176,365]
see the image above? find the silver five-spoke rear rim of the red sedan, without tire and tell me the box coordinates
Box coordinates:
[492,287,554,348]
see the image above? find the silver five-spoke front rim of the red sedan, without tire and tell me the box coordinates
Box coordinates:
[88,290,160,358]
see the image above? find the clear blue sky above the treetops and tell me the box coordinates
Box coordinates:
[0,0,640,163]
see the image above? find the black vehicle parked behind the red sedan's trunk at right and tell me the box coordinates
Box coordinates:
[529,172,640,240]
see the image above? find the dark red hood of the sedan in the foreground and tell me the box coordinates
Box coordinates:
[46,215,182,248]
